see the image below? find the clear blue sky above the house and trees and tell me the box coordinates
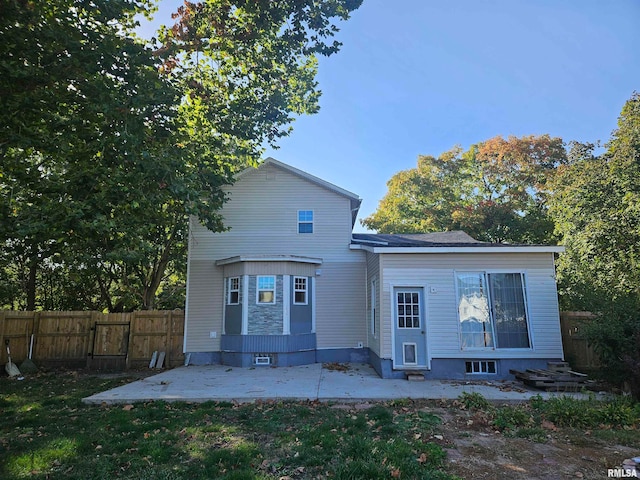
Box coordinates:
[140,0,640,232]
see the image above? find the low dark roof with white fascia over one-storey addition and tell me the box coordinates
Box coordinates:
[351,230,564,253]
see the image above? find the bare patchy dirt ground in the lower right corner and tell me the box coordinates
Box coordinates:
[429,407,640,480]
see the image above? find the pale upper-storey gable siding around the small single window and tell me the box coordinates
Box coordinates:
[191,165,360,262]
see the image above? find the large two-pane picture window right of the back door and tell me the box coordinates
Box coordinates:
[456,272,531,349]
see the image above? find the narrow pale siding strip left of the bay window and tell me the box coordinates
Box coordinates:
[185,260,224,352]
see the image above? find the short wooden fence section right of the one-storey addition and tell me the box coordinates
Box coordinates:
[560,312,601,371]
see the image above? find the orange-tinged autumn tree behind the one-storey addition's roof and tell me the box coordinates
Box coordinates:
[362,135,567,243]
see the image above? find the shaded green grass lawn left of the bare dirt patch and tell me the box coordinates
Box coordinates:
[0,373,453,480]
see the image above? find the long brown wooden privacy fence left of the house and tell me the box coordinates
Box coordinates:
[0,310,184,370]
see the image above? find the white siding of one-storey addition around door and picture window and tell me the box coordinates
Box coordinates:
[381,253,563,359]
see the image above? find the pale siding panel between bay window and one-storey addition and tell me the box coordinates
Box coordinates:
[316,262,367,348]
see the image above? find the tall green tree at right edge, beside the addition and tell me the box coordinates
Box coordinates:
[551,94,640,308]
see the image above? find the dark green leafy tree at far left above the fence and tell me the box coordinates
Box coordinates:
[0,0,179,309]
